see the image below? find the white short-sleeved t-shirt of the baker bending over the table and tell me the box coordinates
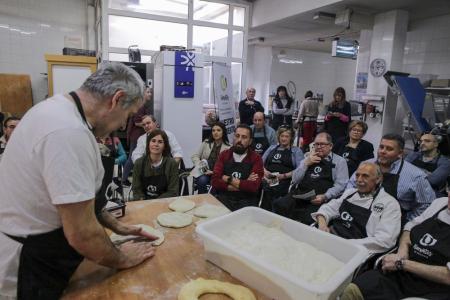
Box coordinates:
[0,95,104,298]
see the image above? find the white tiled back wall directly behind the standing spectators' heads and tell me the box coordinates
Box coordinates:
[270,48,356,104]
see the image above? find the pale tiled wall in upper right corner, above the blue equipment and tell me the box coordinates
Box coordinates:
[403,15,450,78]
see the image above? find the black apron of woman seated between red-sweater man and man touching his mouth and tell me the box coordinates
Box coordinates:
[264,146,294,197]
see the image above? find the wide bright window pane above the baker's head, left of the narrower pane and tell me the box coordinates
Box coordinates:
[109,15,187,51]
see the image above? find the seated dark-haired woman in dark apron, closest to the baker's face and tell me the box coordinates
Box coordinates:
[132,129,178,200]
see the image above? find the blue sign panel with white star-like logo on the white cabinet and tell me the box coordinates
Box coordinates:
[174,51,195,98]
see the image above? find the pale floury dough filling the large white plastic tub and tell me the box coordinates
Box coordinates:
[225,222,344,283]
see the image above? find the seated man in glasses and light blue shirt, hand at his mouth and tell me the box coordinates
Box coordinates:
[273,132,348,224]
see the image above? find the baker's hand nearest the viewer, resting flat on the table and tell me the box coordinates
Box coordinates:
[118,241,155,269]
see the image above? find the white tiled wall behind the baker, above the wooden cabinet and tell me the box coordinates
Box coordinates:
[0,0,94,103]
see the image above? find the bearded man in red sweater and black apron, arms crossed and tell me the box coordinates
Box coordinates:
[211,124,264,211]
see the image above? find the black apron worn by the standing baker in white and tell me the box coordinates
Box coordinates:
[3,92,102,300]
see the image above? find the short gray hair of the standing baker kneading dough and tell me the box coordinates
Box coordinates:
[81,62,144,108]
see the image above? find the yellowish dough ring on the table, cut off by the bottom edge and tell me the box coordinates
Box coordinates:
[178,278,256,300]
